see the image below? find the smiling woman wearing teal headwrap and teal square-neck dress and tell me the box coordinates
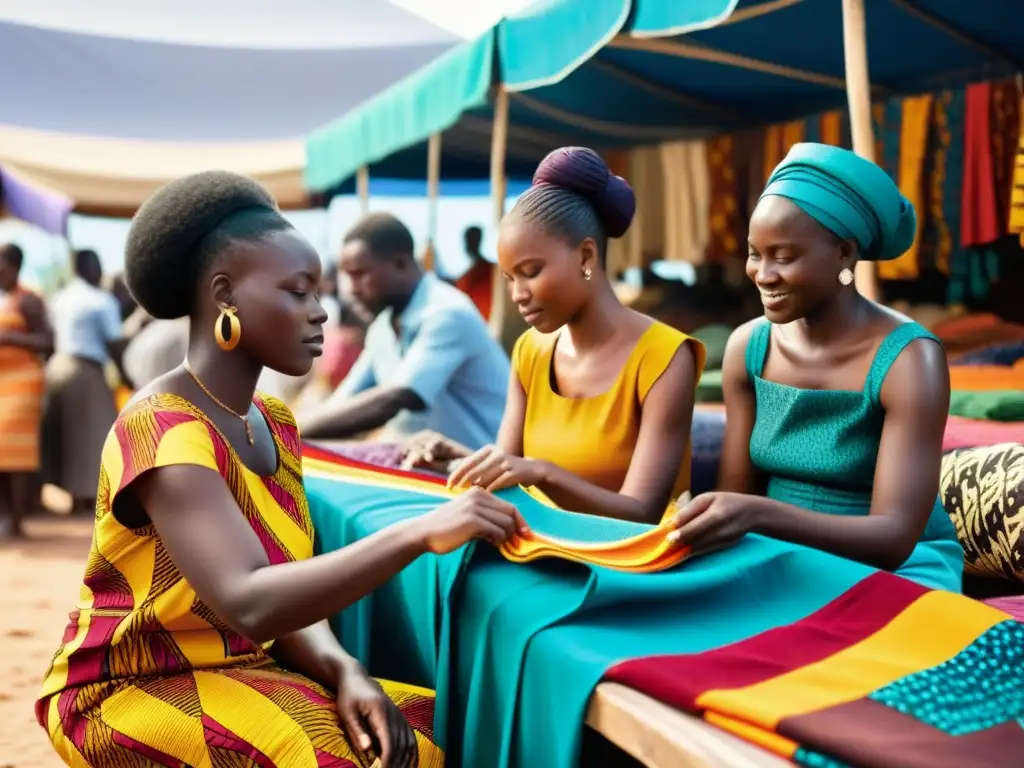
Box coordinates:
[672,143,964,592]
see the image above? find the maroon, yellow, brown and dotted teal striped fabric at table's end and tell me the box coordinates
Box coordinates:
[605,572,1024,768]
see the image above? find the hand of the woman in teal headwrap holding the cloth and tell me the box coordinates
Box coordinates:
[669,492,753,553]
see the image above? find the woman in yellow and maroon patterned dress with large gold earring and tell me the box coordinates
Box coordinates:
[36,172,524,768]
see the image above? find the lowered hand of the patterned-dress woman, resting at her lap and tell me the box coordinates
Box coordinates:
[338,665,419,768]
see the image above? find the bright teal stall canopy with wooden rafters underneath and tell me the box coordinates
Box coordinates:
[305,0,1024,189]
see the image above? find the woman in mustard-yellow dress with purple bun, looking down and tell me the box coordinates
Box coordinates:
[406,146,705,523]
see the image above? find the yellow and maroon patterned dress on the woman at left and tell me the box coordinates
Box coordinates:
[36,394,443,768]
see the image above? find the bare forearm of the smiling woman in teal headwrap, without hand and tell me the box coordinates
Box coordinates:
[751,497,921,570]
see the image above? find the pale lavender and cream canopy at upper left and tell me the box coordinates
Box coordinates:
[0,0,461,222]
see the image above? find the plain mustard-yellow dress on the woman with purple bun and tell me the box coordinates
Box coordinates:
[512,321,705,518]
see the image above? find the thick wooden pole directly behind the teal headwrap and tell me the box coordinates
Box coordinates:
[843,0,880,301]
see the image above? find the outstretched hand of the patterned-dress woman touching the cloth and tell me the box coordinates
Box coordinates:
[418,488,529,555]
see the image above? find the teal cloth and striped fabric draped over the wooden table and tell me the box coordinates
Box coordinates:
[304,453,1024,768]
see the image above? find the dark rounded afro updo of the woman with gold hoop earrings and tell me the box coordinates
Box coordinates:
[125,171,292,319]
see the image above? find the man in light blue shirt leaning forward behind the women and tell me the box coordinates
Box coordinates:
[301,213,509,450]
